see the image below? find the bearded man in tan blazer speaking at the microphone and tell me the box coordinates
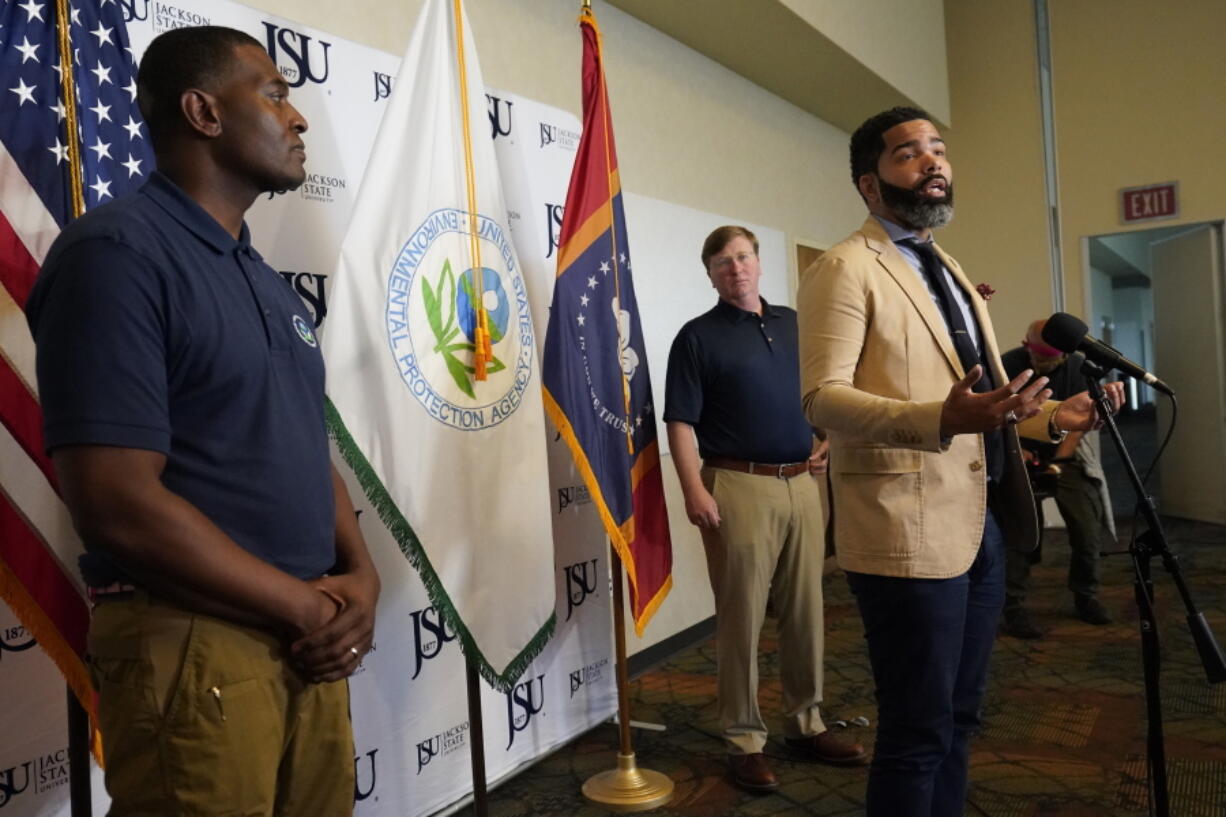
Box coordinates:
[798,108,1122,817]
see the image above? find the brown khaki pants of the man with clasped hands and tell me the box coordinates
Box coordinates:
[89,593,353,817]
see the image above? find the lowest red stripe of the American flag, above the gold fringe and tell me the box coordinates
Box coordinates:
[0,494,89,655]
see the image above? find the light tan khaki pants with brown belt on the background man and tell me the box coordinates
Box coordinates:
[702,467,825,754]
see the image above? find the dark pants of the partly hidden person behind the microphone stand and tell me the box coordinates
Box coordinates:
[1005,461,1116,606]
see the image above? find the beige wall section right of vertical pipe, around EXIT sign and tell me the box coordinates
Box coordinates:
[1052,0,1226,313]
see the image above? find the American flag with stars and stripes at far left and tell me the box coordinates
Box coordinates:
[0,0,153,710]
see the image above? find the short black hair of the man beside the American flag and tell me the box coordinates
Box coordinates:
[136,26,264,151]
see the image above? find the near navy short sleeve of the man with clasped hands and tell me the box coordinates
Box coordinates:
[29,238,170,454]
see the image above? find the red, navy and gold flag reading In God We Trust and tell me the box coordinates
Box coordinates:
[542,10,673,635]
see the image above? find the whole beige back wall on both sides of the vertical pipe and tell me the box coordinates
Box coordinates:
[940,0,1226,346]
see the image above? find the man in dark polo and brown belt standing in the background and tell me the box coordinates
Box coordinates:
[664,226,867,791]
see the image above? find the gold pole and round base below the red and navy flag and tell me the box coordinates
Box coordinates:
[584,539,673,812]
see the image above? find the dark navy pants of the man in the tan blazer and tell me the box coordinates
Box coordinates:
[847,510,1004,817]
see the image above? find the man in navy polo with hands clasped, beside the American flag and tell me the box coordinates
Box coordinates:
[27,27,379,816]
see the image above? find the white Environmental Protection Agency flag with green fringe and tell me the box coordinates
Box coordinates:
[324,0,554,691]
